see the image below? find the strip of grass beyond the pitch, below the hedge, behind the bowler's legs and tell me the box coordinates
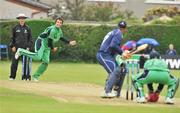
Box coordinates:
[0,62,106,85]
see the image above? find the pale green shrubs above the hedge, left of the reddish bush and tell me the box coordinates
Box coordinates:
[55,0,134,22]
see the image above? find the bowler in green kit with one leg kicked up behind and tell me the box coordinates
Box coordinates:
[15,17,76,81]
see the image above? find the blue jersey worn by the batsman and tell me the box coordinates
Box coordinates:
[99,29,123,55]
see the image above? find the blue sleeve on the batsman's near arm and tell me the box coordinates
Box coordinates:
[109,34,123,55]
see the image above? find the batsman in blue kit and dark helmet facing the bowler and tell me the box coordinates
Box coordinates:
[96,21,128,98]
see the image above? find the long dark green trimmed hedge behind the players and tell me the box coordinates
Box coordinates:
[0,20,180,62]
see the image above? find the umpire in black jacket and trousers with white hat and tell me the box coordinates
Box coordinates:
[9,14,33,80]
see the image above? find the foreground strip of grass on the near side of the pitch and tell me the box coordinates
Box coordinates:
[0,88,179,113]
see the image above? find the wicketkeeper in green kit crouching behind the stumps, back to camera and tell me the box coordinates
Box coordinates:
[132,51,179,104]
